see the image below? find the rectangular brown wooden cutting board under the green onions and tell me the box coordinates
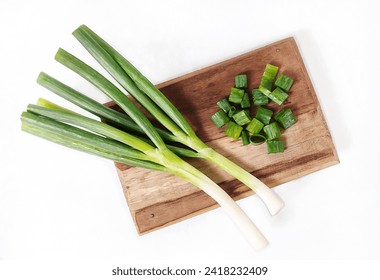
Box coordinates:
[112,38,339,234]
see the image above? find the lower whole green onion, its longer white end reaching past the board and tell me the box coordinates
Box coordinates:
[21,103,267,250]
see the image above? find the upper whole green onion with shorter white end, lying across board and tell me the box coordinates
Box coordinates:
[65,25,284,215]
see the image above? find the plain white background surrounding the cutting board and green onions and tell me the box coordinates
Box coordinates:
[0,0,380,272]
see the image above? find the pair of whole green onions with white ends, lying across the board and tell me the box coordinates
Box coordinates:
[21,25,284,249]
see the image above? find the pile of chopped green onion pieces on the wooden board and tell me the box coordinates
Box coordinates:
[211,64,297,154]
